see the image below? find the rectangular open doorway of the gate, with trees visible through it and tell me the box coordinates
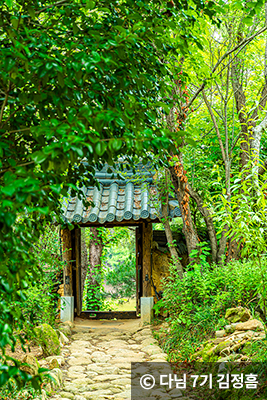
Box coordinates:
[81,226,140,318]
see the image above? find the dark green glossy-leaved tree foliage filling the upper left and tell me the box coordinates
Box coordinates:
[0,0,191,384]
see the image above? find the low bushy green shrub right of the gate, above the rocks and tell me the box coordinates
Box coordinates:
[155,258,267,360]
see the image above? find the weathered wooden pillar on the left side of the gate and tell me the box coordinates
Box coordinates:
[61,228,73,296]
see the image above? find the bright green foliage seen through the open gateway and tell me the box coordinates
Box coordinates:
[83,227,136,311]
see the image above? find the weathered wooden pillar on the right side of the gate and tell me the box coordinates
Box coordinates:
[142,223,152,297]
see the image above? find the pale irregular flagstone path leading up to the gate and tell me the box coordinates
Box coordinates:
[51,320,170,400]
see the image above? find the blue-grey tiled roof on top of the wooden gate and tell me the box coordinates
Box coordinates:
[63,166,181,224]
